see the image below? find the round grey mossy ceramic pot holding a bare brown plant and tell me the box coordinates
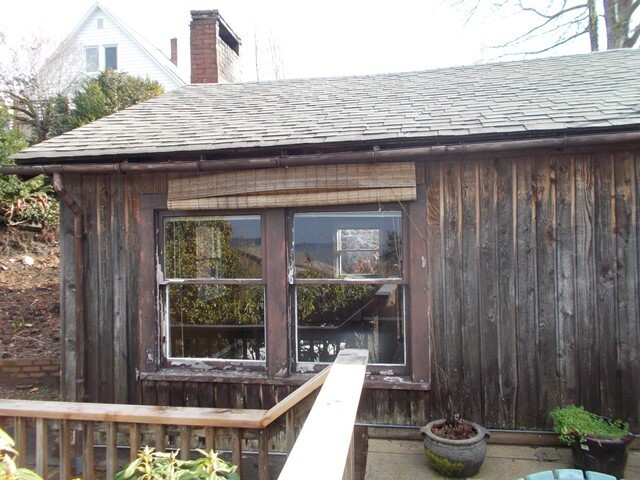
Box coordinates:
[420,419,489,477]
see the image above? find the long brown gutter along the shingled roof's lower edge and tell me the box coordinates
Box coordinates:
[0,131,640,176]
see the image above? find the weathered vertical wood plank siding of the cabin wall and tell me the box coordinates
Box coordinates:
[61,151,640,430]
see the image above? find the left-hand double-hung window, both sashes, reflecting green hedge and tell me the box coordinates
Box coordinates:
[160,215,266,361]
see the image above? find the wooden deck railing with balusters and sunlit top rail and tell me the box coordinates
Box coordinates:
[0,350,366,480]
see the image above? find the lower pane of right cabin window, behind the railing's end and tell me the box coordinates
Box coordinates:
[296,284,405,365]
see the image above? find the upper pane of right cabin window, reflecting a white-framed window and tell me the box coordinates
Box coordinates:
[293,212,402,278]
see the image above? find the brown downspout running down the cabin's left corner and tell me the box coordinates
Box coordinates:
[53,173,87,402]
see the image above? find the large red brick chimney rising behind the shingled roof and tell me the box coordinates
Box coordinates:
[190,10,240,83]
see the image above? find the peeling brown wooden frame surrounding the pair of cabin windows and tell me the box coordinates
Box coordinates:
[138,185,431,390]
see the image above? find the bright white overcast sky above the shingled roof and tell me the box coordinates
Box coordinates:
[0,0,588,81]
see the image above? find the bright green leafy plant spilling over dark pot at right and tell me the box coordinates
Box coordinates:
[550,405,629,445]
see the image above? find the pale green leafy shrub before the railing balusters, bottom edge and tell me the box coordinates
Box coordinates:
[114,447,240,480]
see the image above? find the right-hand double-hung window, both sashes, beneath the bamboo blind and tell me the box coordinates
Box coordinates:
[292,211,406,365]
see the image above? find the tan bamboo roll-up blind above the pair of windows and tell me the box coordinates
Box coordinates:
[167,162,416,210]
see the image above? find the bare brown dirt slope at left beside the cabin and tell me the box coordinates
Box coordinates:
[0,226,60,400]
